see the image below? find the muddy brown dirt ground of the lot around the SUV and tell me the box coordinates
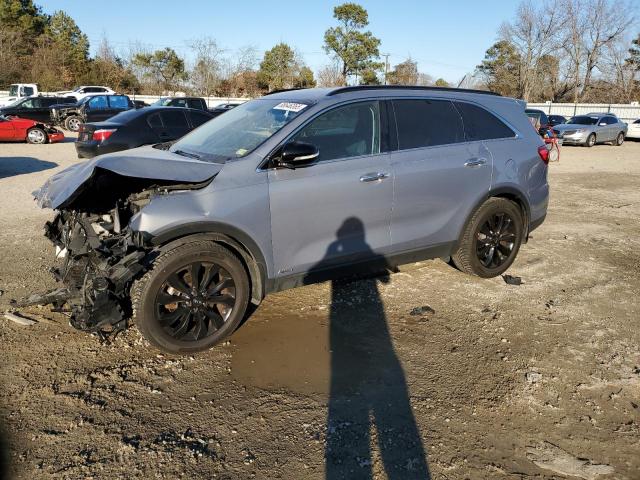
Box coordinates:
[0,136,640,480]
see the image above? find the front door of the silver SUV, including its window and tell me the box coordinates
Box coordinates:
[268,101,393,277]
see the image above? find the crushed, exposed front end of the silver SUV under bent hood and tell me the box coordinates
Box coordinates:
[21,150,219,340]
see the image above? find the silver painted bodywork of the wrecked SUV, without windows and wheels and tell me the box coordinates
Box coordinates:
[36,89,549,286]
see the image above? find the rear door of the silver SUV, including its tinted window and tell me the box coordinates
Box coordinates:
[391,98,492,255]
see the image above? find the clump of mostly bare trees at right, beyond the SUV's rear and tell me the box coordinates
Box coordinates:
[477,0,640,103]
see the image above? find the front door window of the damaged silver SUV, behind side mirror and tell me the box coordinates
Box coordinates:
[290,102,380,161]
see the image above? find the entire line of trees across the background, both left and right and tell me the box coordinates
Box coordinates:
[0,0,640,102]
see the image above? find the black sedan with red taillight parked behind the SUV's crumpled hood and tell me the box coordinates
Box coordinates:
[75,107,214,158]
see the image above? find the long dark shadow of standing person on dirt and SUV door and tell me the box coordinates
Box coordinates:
[305,217,431,480]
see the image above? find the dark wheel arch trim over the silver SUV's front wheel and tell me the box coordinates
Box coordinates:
[149,222,267,305]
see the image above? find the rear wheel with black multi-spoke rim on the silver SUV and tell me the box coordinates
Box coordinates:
[451,197,524,278]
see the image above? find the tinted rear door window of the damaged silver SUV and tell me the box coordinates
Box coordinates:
[393,99,464,150]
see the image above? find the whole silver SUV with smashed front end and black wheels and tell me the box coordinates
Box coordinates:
[31,87,549,353]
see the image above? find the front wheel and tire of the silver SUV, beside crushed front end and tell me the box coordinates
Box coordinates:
[131,241,250,353]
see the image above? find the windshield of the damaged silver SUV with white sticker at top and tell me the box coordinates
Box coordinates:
[170,99,308,162]
